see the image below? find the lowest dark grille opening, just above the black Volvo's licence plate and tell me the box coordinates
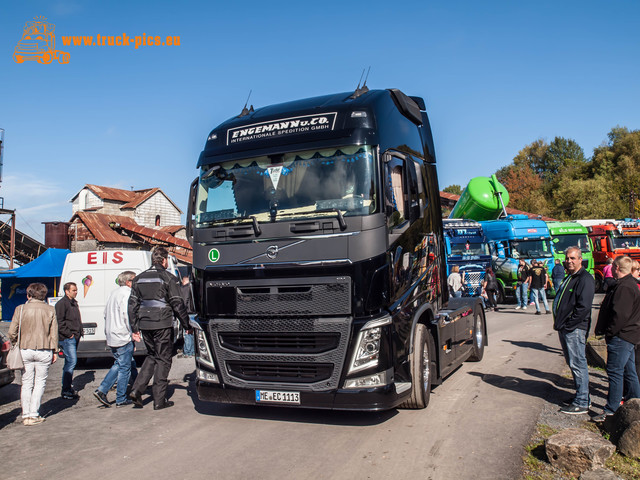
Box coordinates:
[227,362,333,383]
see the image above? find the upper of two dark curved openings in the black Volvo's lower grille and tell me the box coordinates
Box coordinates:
[219,332,340,354]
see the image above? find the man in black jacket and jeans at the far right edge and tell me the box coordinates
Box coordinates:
[594,256,640,421]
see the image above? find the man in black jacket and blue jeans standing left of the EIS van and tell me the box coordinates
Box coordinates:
[56,282,83,400]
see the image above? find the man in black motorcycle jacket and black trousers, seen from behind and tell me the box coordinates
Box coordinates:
[129,247,189,410]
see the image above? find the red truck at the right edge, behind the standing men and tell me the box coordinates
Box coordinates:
[588,218,640,292]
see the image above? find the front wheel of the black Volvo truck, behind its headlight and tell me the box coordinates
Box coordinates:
[401,323,436,409]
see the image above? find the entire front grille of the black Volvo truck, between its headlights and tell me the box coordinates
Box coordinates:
[207,277,352,392]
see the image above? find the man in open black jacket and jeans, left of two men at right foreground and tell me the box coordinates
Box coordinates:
[553,247,595,415]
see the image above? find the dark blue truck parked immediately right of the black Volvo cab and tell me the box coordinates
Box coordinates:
[442,218,491,297]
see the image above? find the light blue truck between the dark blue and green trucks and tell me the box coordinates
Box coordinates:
[480,215,553,303]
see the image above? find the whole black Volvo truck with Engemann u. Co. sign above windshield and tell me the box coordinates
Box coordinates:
[187,87,487,410]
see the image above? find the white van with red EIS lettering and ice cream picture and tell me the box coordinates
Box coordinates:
[49,250,179,358]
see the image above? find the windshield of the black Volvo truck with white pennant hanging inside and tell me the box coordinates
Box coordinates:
[195,145,378,227]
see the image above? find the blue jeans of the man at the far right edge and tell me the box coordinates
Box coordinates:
[604,337,640,414]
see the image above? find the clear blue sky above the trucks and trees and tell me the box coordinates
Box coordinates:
[0,0,640,244]
